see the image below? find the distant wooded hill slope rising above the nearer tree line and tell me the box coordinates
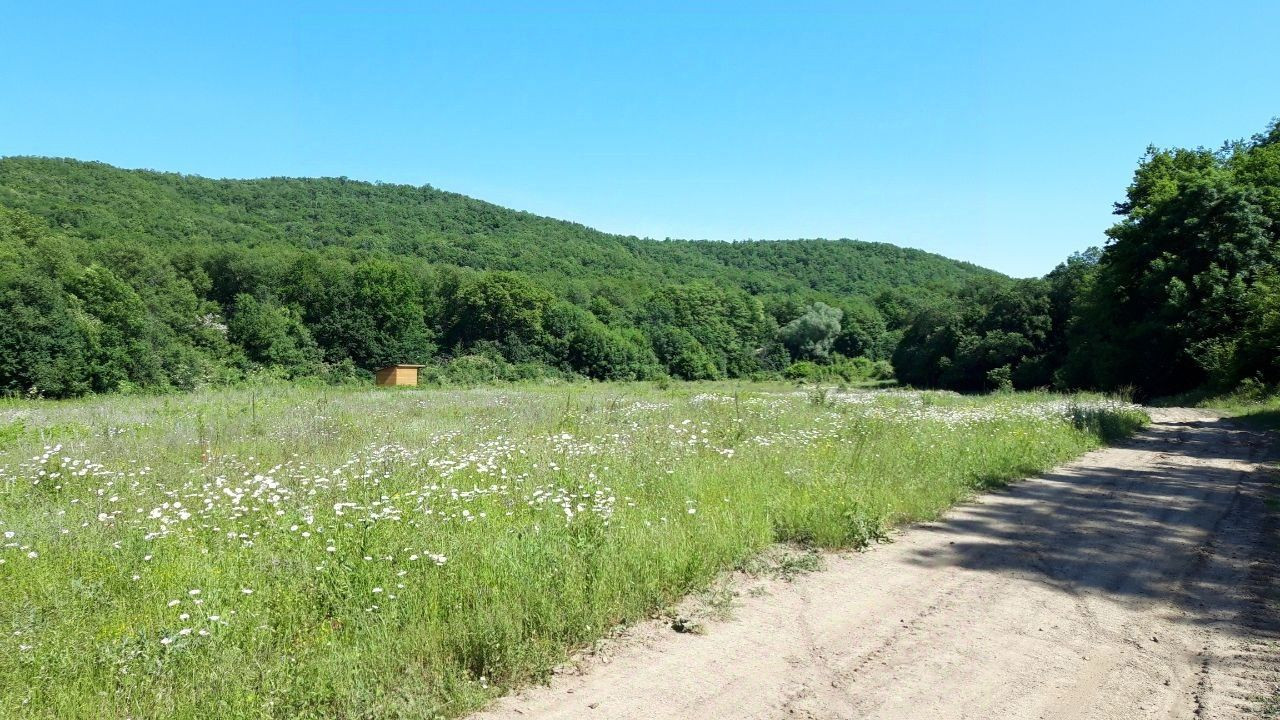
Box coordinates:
[0,158,995,297]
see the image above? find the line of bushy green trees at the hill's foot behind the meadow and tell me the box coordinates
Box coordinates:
[0,208,891,397]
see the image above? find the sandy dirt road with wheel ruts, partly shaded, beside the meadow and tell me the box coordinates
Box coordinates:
[479,410,1280,720]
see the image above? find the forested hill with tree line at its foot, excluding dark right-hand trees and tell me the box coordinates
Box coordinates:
[0,158,993,397]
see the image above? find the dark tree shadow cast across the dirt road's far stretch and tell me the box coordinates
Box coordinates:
[910,420,1276,632]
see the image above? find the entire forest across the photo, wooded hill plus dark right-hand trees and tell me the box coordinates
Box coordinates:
[0,122,1280,397]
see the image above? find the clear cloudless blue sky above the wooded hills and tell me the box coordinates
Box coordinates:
[0,0,1280,275]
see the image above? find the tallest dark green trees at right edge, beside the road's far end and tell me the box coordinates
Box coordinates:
[1073,126,1280,395]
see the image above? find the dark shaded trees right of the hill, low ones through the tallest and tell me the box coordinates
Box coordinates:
[893,122,1280,397]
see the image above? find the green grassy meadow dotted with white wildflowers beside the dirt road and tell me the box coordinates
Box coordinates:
[0,384,1144,719]
